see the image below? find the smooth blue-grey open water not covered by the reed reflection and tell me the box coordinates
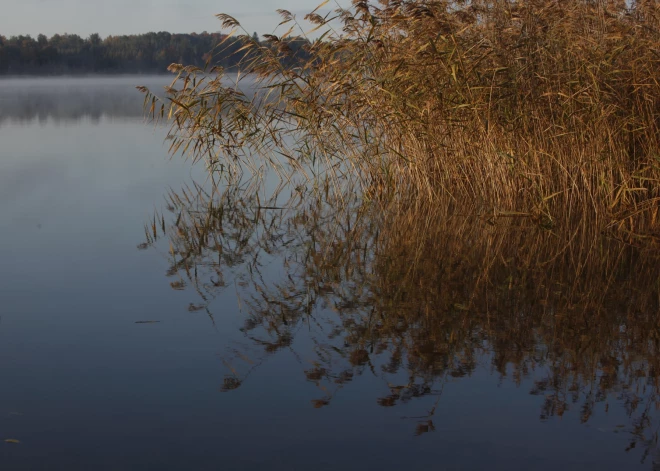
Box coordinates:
[0,77,657,471]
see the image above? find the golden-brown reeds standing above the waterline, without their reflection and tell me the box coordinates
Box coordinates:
[142,0,660,240]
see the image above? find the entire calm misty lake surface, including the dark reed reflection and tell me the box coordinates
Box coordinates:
[0,77,660,471]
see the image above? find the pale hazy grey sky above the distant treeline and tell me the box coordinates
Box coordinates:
[0,0,350,37]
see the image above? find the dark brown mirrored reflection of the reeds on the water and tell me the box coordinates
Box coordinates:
[145,180,660,460]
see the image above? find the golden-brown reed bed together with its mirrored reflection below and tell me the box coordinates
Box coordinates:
[143,0,660,460]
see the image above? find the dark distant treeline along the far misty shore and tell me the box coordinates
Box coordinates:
[0,32,306,75]
